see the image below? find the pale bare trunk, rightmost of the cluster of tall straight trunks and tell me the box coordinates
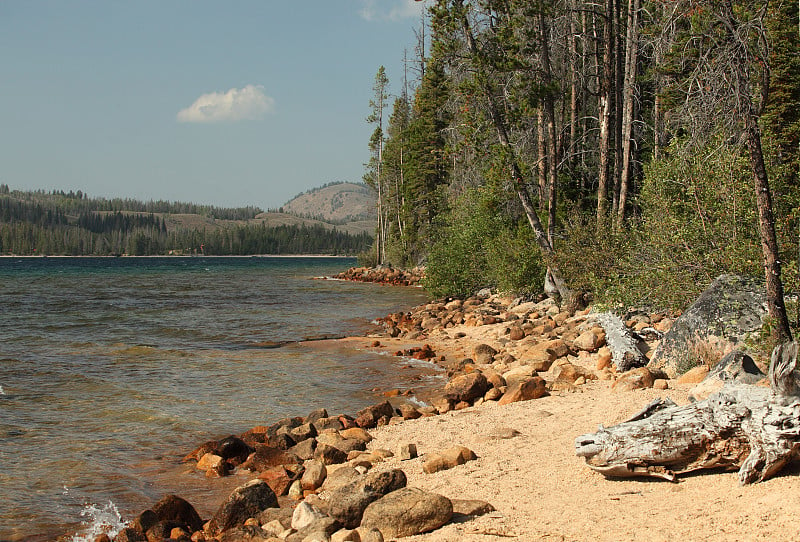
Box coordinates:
[617,0,639,228]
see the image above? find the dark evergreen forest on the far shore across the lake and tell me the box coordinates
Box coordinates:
[0,185,372,256]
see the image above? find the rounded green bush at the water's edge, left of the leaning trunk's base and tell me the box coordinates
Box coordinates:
[425,188,545,297]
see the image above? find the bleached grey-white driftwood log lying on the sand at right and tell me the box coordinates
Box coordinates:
[575,343,800,484]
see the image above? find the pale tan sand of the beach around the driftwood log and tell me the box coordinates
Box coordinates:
[334,334,800,542]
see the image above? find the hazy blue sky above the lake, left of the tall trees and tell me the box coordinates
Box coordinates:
[0,0,424,209]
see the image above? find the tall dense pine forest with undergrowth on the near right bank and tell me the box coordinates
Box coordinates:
[363,0,800,338]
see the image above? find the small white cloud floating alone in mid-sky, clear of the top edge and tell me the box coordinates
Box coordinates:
[177,85,275,122]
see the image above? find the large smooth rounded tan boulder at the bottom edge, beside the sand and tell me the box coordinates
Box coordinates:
[361,487,453,538]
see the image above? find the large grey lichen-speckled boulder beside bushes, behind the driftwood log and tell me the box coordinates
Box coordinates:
[648,275,767,378]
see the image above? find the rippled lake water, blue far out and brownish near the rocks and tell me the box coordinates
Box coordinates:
[0,257,432,541]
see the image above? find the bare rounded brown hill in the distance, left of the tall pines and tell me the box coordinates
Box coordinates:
[281,183,377,225]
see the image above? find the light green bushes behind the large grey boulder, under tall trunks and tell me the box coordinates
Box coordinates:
[557,138,763,309]
